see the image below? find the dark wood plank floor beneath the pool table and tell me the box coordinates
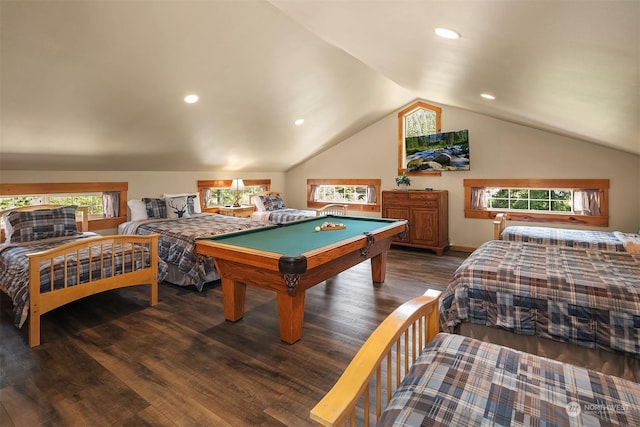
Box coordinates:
[0,249,467,427]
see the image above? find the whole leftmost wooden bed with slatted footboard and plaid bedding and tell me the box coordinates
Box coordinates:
[0,205,166,347]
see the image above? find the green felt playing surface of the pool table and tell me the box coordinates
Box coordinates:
[202,216,396,257]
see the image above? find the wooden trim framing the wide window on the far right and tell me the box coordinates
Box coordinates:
[464,179,609,227]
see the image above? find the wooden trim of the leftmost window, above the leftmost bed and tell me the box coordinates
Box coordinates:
[0,182,129,231]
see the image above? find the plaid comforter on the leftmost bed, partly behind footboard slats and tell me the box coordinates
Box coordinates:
[0,233,167,328]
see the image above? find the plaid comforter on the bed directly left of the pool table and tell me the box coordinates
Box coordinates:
[119,214,271,291]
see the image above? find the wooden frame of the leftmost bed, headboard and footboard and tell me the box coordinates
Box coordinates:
[0,205,158,347]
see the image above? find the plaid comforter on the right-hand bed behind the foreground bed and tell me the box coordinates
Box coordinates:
[440,240,640,358]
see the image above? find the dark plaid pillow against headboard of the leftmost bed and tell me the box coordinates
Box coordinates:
[5,206,81,243]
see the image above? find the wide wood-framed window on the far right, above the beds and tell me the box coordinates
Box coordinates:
[464,179,609,227]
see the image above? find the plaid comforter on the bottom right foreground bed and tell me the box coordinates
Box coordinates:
[378,334,640,427]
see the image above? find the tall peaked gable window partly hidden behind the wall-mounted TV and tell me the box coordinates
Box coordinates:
[398,101,442,175]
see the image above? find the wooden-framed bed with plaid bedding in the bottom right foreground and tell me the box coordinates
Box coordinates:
[310,291,640,426]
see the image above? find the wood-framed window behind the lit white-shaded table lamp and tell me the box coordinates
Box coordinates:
[198,179,271,212]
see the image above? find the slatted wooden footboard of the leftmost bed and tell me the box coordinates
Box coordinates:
[27,234,158,347]
